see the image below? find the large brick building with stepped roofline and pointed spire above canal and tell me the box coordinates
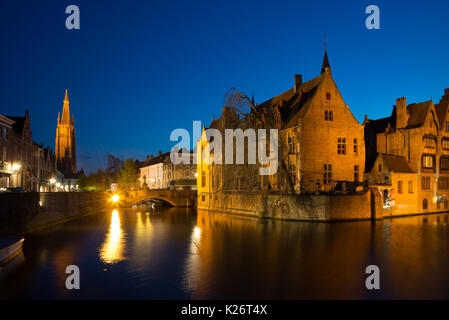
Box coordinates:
[197,51,365,200]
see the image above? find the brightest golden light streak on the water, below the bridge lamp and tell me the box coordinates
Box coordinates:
[100,210,125,263]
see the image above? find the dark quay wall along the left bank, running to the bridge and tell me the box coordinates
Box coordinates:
[0,192,109,236]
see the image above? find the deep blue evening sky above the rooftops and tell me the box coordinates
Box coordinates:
[0,0,449,171]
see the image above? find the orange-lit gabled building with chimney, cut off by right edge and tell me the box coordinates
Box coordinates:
[364,89,449,213]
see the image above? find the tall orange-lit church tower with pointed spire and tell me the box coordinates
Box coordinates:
[55,89,76,177]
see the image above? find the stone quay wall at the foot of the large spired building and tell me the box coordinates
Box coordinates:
[198,190,374,221]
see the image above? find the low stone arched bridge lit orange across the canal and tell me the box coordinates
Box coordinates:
[120,189,197,207]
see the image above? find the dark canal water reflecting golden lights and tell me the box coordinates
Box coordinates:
[0,208,449,299]
